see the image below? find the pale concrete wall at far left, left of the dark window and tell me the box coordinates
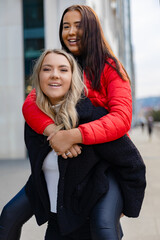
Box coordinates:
[0,0,25,159]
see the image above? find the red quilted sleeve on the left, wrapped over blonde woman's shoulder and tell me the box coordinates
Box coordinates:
[22,89,53,134]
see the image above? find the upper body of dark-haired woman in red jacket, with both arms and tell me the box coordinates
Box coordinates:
[23,5,132,149]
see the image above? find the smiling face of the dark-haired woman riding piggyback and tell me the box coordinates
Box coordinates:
[62,10,83,56]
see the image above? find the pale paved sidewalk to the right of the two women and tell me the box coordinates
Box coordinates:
[121,128,160,240]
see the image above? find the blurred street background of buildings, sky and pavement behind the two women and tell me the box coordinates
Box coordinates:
[0,0,160,240]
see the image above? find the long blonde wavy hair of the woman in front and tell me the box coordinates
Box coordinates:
[31,49,87,132]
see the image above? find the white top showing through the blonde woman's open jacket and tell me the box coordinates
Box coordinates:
[42,150,59,213]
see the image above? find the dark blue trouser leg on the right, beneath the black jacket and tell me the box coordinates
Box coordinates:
[90,172,123,240]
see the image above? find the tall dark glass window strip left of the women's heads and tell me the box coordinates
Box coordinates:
[23,0,44,95]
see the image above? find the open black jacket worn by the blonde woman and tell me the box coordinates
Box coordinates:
[25,98,146,235]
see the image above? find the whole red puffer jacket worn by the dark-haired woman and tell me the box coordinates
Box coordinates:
[22,61,132,145]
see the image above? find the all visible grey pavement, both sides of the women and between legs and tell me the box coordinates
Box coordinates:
[0,125,160,240]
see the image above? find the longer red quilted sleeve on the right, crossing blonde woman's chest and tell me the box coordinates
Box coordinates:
[79,66,132,145]
